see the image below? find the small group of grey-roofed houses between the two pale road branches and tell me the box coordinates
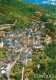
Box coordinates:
[18,47,32,66]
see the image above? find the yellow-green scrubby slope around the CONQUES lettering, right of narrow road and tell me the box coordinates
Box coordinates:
[24,45,56,80]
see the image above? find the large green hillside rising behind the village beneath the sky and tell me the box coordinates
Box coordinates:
[0,0,52,29]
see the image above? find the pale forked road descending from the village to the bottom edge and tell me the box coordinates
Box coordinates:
[0,47,29,80]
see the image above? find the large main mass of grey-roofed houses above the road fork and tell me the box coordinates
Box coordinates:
[0,24,51,52]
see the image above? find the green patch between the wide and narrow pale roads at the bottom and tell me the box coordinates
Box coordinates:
[10,63,22,80]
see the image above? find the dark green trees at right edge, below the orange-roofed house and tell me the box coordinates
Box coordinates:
[44,42,56,59]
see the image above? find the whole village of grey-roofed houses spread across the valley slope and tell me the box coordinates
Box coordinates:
[0,22,52,80]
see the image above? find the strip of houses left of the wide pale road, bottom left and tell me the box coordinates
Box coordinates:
[0,54,17,75]
